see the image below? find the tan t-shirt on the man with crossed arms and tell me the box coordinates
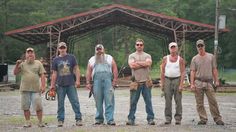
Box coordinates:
[128,52,152,82]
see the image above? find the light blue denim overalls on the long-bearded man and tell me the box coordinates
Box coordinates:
[93,72,115,123]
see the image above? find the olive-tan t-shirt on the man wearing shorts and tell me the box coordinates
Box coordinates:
[19,60,46,92]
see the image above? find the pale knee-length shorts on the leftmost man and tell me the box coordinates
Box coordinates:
[21,91,43,111]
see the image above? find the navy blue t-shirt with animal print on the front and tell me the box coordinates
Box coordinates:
[52,54,77,86]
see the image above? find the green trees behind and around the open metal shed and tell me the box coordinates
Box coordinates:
[0,0,236,68]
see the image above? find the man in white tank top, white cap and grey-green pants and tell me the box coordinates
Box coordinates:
[161,42,185,125]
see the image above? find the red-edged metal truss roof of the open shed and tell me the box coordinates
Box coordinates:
[5,4,229,69]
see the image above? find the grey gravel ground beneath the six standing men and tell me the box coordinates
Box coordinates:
[0,88,236,132]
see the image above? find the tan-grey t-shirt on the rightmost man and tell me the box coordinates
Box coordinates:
[190,53,216,79]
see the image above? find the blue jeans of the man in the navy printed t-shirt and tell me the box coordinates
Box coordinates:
[56,86,82,121]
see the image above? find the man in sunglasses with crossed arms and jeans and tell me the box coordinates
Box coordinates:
[126,39,155,125]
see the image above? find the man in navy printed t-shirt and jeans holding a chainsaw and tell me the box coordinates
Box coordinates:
[51,42,82,127]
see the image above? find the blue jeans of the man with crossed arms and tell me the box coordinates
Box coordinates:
[128,84,154,121]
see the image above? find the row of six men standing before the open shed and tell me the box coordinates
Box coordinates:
[14,39,224,127]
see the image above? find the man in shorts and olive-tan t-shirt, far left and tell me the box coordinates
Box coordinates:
[14,48,45,128]
